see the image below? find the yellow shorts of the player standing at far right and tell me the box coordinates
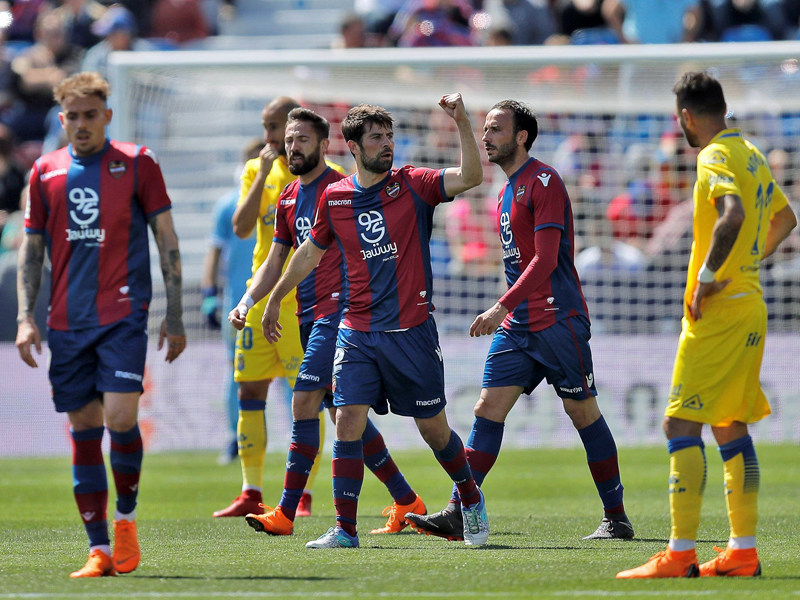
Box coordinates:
[665,294,770,427]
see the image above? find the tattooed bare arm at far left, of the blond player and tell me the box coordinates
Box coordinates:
[16,233,44,368]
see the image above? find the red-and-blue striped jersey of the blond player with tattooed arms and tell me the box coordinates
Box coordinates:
[25,140,171,331]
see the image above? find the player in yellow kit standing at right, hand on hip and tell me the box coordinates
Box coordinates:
[617,73,797,579]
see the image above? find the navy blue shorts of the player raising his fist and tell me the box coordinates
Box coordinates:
[333,317,446,419]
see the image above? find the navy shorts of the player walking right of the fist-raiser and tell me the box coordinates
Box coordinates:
[483,317,597,400]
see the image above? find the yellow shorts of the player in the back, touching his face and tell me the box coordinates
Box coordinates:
[233,293,303,388]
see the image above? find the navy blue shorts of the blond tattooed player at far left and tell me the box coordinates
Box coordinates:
[48,310,147,412]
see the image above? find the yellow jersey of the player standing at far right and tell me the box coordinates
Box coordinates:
[684,129,787,312]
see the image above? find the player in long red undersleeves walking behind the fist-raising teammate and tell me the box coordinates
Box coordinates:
[406,100,633,539]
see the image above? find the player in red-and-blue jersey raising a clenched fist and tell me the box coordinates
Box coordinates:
[262,94,489,548]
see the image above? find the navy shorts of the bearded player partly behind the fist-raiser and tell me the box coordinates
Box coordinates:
[294,313,341,408]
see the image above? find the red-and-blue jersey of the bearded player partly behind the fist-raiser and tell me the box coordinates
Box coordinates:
[272,167,346,325]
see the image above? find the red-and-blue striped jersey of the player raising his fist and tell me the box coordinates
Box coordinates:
[311,166,450,331]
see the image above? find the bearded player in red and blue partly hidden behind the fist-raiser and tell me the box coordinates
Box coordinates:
[229,108,426,535]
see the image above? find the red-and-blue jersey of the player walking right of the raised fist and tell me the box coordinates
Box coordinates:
[497,158,589,331]
